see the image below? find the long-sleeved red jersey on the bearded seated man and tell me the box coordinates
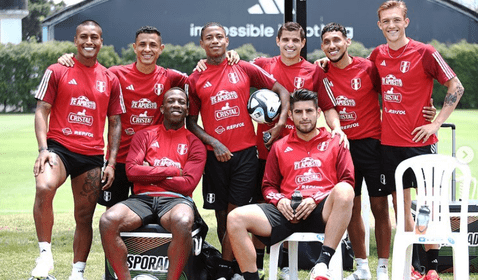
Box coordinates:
[262,127,354,206]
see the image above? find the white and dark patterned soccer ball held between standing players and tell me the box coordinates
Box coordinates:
[247,89,281,123]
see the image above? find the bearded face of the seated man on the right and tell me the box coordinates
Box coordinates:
[289,100,319,134]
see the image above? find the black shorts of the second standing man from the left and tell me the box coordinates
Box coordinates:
[98,163,133,207]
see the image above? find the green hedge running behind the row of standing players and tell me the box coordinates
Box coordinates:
[0,38,478,112]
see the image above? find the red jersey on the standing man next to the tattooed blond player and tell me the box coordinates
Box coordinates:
[326,57,381,140]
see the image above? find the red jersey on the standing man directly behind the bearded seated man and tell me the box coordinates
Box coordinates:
[252,56,335,159]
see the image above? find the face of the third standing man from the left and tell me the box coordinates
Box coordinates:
[199,26,229,57]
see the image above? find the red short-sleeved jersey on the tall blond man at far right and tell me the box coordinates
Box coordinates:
[369,39,456,147]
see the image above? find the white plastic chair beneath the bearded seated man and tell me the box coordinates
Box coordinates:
[269,232,345,280]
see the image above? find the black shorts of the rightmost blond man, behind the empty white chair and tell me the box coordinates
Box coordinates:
[381,144,436,192]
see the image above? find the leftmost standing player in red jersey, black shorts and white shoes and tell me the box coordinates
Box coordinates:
[32,20,125,280]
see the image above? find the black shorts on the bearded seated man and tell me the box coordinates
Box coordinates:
[257,197,327,246]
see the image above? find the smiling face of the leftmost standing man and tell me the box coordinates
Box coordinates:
[74,24,103,59]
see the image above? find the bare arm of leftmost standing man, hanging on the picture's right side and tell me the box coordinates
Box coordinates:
[101,115,121,190]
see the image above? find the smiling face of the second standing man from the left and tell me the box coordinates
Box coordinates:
[133,33,164,65]
